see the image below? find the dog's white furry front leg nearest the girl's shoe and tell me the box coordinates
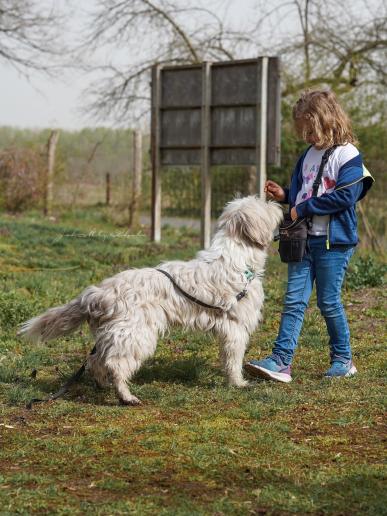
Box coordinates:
[219,322,249,387]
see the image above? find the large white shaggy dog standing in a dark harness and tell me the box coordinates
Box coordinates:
[19,195,282,405]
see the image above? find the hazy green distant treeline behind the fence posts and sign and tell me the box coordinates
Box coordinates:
[0,108,387,240]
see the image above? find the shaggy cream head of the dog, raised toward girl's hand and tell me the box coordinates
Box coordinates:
[218,195,283,247]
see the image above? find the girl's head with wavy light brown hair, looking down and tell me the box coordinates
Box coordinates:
[293,90,358,149]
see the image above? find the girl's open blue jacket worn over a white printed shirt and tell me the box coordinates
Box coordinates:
[283,147,374,249]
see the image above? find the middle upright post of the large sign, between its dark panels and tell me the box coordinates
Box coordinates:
[200,62,211,249]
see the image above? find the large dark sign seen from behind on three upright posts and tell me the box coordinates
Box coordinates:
[151,56,281,247]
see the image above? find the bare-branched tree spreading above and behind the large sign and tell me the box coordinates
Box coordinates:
[82,0,387,121]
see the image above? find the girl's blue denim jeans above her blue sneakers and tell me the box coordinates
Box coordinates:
[273,236,355,365]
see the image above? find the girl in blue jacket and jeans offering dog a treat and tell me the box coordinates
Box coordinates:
[245,90,373,382]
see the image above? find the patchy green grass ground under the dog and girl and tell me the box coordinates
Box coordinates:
[0,208,387,515]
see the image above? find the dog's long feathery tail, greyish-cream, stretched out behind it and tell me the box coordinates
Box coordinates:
[17,285,102,342]
